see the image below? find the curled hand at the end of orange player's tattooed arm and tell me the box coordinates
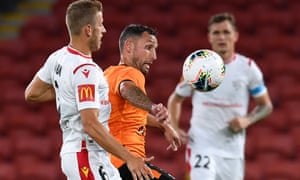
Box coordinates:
[150,103,169,123]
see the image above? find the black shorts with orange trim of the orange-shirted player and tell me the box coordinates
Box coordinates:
[118,163,175,180]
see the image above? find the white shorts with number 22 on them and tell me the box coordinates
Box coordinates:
[186,147,245,180]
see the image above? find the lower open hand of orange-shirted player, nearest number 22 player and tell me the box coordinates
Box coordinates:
[163,124,182,151]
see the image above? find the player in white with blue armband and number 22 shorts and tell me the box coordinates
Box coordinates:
[168,13,273,180]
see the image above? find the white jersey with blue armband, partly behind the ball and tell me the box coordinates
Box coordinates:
[176,54,267,158]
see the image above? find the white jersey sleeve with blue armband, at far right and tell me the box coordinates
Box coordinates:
[249,61,267,97]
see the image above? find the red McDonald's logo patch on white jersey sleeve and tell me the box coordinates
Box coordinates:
[78,84,95,102]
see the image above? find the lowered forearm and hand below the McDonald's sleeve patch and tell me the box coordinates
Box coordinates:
[80,109,153,180]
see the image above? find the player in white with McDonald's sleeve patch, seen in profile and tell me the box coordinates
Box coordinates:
[25,0,153,180]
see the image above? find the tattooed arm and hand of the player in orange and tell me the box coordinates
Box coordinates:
[119,80,168,122]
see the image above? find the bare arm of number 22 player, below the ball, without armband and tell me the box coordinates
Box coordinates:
[168,91,188,143]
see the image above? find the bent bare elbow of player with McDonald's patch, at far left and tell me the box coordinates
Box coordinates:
[25,75,55,102]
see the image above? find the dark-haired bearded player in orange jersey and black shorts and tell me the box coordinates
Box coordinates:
[104,24,181,180]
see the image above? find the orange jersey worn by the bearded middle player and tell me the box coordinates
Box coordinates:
[104,65,148,168]
